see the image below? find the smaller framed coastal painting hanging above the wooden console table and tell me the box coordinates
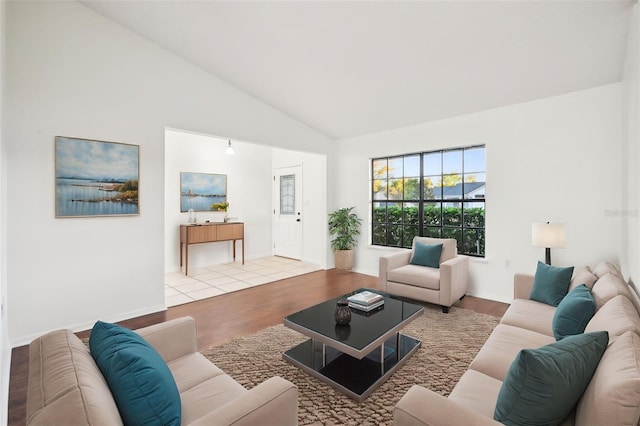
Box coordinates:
[180,172,227,212]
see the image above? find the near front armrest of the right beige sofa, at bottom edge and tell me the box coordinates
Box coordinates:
[393,385,500,426]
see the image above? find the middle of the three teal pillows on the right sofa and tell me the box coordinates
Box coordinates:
[551,284,596,340]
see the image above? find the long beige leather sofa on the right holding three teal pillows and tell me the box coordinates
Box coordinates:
[394,262,640,425]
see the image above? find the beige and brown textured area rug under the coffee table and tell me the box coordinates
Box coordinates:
[203,306,499,425]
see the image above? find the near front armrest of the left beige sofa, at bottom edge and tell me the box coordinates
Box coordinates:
[192,376,298,426]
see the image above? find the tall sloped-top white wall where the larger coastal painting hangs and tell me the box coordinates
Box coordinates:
[4,1,330,345]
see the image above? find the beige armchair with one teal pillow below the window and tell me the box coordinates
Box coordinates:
[378,237,469,313]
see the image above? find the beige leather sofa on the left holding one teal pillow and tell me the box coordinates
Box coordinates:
[27,317,298,426]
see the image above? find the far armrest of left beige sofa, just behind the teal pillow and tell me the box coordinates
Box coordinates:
[135,317,198,362]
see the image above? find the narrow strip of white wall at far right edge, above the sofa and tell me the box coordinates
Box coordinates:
[620,4,640,288]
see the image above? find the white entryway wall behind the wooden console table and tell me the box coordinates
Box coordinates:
[165,130,272,272]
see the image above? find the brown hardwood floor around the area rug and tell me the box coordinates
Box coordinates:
[8,269,509,426]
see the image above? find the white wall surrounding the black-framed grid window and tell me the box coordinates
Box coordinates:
[334,84,622,302]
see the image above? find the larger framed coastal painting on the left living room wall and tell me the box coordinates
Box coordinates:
[55,136,140,217]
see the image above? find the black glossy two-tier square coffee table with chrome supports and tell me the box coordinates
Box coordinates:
[282,289,424,402]
